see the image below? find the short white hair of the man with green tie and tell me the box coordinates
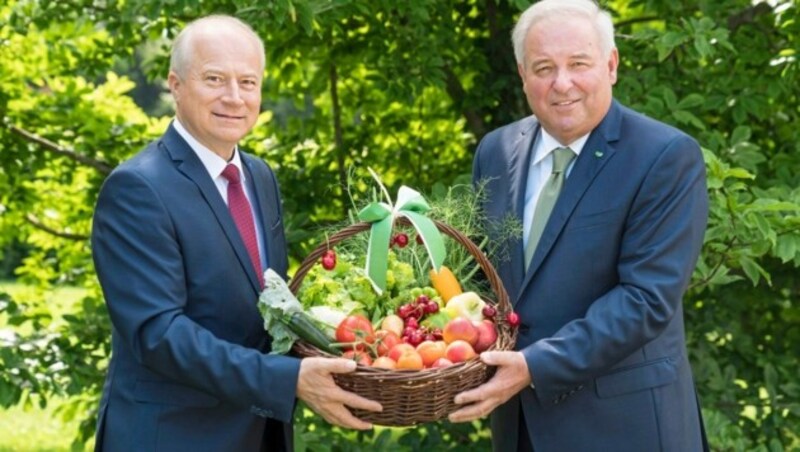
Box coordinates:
[511,0,617,64]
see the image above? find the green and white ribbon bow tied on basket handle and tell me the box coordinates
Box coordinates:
[358,185,447,294]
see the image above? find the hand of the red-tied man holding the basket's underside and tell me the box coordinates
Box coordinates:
[297,358,383,430]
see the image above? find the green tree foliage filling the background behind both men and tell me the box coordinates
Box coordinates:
[0,0,800,450]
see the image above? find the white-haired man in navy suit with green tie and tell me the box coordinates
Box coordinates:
[451,0,708,452]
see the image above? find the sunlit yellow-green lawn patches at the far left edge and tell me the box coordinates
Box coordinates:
[0,281,93,452]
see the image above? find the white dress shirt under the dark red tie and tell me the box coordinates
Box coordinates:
[172,118,267,270]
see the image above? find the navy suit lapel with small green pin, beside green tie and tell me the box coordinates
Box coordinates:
[520,101,622,295]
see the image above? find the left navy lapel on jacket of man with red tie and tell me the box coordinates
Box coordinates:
[161,125,260,292]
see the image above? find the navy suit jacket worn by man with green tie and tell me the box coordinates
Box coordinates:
[473,101,708,452]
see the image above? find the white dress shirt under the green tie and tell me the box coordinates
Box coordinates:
[522,127,589,249]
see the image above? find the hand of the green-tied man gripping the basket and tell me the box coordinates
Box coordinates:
[448,351,531,422]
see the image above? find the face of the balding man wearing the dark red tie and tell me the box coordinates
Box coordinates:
[169,28,263,160]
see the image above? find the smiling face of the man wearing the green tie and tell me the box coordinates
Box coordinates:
[518,17,618,145]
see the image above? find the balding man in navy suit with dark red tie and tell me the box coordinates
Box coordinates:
[92,16,381,451]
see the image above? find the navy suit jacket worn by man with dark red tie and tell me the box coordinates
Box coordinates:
[92,126,299,451]
